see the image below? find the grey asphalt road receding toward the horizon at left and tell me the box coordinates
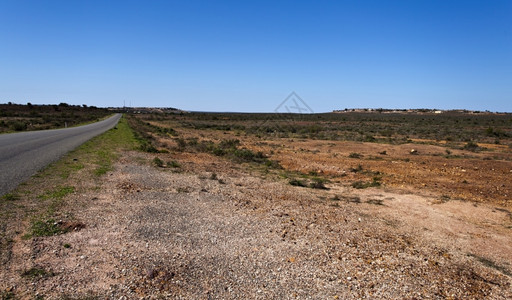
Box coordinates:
[0,114,121,195]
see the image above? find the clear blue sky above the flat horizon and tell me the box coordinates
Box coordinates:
[0,0,512,112]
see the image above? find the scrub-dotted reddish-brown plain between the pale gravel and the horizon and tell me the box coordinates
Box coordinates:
[136,112,512,207]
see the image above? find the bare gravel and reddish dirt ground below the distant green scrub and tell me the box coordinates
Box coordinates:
[0,114,512,299]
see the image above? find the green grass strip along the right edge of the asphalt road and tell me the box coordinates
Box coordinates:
[4,118,135,245]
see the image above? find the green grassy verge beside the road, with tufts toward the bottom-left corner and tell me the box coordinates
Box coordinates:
[0,118,137,299]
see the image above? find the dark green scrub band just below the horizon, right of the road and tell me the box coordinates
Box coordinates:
[150,110,512,144]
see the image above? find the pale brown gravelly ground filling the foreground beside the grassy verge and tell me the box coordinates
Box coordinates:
[0,152,512,299]
